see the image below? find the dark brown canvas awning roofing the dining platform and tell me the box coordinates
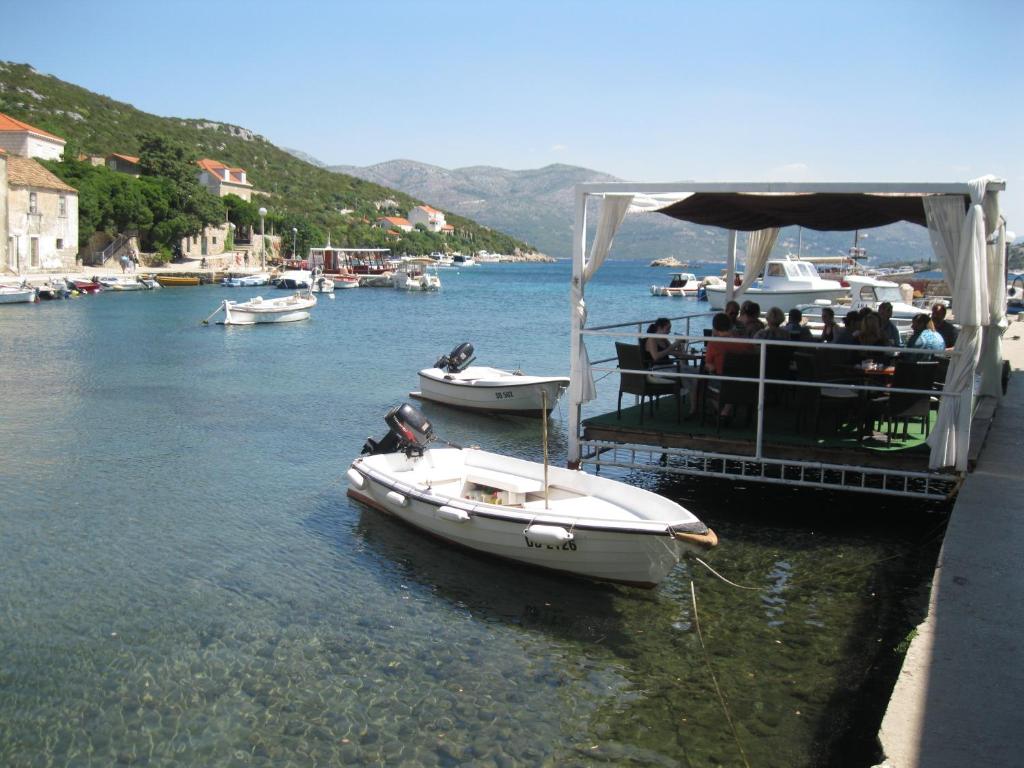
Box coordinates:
[657,193,970,231]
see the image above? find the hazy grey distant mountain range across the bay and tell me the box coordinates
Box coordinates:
[325,154,931,263]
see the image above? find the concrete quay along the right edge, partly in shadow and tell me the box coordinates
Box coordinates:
[879,323,1024,768]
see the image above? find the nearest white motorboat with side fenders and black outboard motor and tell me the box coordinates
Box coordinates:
[347,403,718,588]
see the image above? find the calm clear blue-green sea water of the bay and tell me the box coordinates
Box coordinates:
[0,262,943,766]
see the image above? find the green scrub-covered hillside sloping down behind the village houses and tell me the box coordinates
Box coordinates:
[0,61,536,259]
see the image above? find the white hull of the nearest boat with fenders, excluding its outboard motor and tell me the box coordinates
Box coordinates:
[348,449,717,588]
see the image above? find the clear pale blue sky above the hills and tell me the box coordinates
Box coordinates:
[0,0,1024,234]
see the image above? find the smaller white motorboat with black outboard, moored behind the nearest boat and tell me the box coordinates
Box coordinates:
[412,342,569,416]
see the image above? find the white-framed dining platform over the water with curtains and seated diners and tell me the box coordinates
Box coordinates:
[568,177,1007,500]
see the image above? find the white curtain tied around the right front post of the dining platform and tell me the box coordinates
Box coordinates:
[923,177,1005,470]
